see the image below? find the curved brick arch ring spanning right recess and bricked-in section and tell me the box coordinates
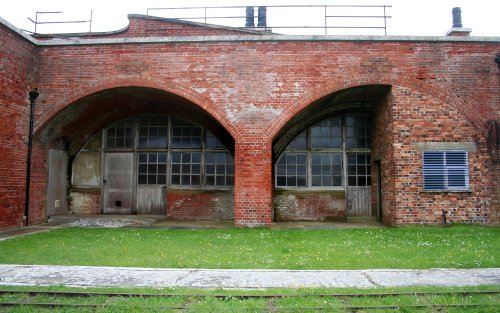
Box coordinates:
[267,74,487,140]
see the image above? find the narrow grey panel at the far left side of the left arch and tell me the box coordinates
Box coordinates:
[45,149,68,217]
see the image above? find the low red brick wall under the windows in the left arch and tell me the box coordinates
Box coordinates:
[166,189,234,220]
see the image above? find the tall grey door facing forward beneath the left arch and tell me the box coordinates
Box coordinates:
[103,152,134,214]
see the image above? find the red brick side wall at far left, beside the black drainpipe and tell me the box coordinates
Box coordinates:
[0,24,35,228]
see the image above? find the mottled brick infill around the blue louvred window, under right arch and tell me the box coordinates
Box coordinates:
[392,87,493,225]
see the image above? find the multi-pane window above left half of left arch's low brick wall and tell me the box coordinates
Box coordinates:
[171,152,201,186]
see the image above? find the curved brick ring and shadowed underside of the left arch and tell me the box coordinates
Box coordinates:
[35,79,234,153]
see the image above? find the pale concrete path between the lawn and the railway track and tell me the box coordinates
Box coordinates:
[0,265,500,289]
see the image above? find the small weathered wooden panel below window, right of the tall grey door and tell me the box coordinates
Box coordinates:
[136,186,166,215]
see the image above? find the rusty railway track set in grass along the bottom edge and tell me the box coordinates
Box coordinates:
[0,290,500,312]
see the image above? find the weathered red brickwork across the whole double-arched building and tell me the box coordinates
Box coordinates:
[0,17,500,227]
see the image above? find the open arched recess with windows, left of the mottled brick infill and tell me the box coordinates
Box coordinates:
[273,85,391,221]
